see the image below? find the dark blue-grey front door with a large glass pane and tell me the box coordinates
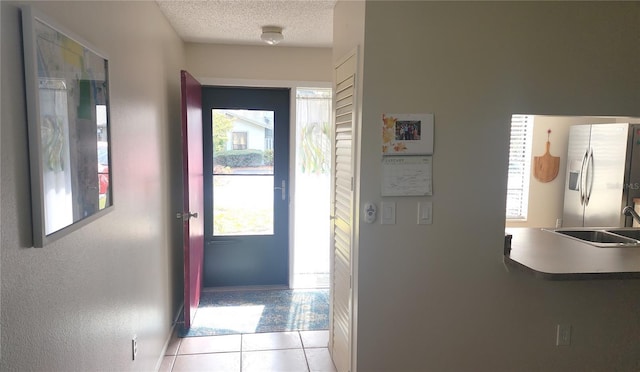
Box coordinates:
[202,87,290,287]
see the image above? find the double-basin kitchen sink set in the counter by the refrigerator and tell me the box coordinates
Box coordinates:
[548,228,640,248]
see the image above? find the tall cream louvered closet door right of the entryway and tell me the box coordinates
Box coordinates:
[330,51,356,372]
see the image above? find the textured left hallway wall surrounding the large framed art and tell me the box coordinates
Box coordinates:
[0,1,184,371]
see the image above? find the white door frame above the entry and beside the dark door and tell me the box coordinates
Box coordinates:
[198,78,333,288]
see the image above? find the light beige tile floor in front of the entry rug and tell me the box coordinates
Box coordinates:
[160,331,336,372]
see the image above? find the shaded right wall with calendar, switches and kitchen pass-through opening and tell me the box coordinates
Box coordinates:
[348,1,640,371]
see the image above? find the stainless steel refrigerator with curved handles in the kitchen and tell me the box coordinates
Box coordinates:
[562,123,640,227]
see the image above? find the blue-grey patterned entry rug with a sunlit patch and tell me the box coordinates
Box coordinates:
[180,289,329,337]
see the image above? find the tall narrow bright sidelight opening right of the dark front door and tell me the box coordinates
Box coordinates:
[292,88,331,288]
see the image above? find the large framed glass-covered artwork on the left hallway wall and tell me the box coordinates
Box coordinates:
[21,6,113,247]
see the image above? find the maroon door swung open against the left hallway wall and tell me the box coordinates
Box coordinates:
[178,71,204,329]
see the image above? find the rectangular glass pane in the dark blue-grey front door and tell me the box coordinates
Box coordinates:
[212,110,274,236]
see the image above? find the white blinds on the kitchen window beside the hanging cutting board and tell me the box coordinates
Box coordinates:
[507,115,533,220]
